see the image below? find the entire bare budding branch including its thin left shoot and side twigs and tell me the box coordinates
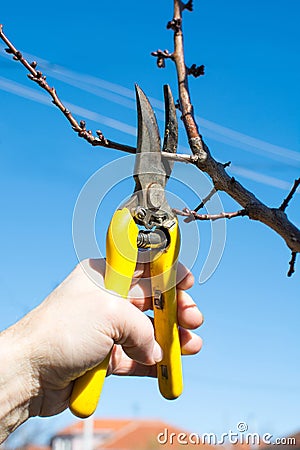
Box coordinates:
[0,9,300,270]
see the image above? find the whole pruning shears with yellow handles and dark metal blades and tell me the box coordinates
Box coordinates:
[70,85,183,418]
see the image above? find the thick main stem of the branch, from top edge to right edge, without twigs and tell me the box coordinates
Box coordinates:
[166,0,300,252]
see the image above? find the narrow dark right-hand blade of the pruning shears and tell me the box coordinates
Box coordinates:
[163,84,178,178]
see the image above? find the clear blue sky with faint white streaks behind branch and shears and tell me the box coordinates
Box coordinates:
[0,0,300,446]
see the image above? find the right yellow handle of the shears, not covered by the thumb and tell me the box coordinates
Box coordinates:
[150,220,183,400]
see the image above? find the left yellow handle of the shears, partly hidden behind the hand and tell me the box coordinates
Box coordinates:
[69,208,139,418]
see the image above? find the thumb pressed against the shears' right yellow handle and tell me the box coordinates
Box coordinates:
[113,299,163,365]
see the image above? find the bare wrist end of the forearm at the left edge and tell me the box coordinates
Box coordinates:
[0,319,33,443]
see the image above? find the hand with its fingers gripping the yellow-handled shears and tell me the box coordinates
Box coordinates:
[0,259,203,424]
